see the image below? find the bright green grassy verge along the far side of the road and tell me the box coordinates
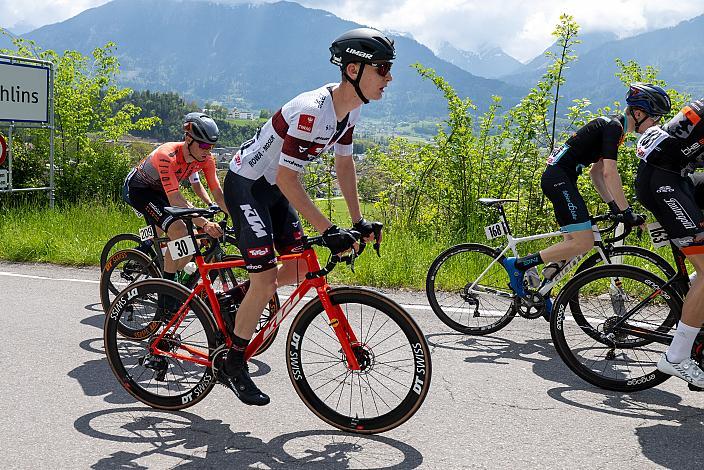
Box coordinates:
[0,199,672,289]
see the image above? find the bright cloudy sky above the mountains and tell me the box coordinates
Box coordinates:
[0,0,704,62]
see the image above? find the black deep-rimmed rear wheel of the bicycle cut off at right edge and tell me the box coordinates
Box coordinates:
[550,264,682,392]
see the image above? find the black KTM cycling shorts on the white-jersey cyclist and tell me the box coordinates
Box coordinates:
[223,171,303,273]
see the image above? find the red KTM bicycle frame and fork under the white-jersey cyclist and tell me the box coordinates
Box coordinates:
[151,244,360,370]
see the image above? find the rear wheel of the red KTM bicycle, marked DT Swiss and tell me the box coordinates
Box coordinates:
[103,279,219,410]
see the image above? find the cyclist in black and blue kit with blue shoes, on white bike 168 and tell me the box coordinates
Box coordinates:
[503,83,670,297]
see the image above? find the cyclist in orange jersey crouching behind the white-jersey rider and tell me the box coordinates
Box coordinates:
[122,112,225,280]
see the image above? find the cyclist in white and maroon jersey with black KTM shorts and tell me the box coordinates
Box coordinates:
[216,28,396,406]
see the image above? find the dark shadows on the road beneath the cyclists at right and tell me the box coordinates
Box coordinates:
[427,333,704,468]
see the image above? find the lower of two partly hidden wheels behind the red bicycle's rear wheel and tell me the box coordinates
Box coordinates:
[99,249,161,337]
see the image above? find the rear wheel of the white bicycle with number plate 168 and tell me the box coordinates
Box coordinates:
[425,243,516,335]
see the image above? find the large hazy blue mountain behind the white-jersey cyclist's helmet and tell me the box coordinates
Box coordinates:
[2,0,523,120]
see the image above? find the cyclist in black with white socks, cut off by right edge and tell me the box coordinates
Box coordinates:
[636,94,704,387]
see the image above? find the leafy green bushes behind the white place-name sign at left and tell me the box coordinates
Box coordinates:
[0,29,158,202]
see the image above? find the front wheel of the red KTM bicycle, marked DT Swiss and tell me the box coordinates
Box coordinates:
[286,288,431,434]
